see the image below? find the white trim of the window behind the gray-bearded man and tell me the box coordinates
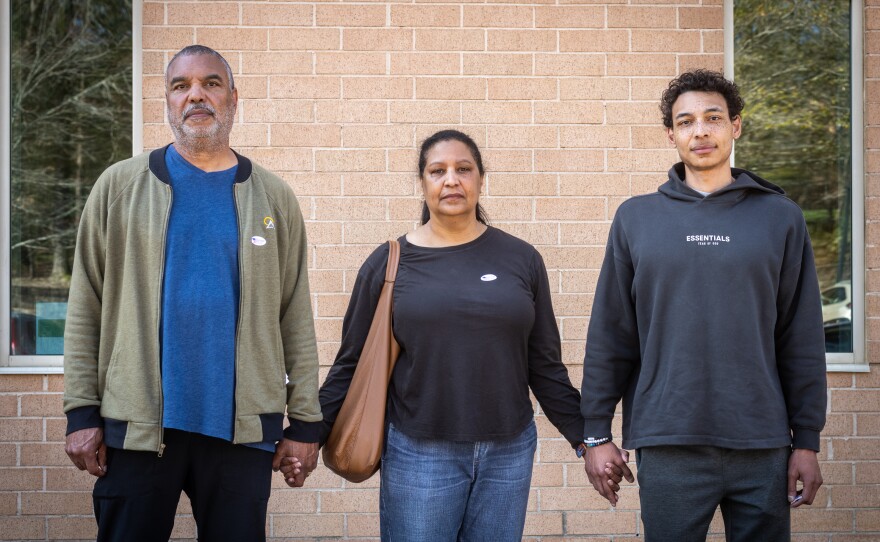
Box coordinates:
[0,0,144,374]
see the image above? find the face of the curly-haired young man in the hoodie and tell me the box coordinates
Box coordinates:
[666,91,742,176]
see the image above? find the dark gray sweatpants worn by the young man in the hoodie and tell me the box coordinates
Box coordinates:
[636,446,791,542]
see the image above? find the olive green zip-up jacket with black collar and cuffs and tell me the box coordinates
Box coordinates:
[64,147,322,453]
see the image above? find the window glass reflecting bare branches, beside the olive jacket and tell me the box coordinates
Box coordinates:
[9,0,132,355]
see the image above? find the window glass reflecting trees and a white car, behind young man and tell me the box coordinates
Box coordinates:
[734,0,852,352]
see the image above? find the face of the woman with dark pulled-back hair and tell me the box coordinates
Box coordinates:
[422,139,483,225]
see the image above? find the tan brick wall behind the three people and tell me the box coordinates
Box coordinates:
[0,0,880,542]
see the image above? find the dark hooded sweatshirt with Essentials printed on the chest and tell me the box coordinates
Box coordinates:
[581,163,826,451]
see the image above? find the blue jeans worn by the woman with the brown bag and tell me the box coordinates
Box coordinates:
[379,421,538,542]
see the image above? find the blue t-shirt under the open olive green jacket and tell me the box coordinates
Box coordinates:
[162,145,248,441]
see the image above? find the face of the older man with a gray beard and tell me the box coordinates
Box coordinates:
[165,55,238,148]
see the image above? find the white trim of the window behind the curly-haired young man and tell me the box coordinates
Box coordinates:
[724,0,870,373]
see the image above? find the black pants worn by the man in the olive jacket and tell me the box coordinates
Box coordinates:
[92,429,272,542]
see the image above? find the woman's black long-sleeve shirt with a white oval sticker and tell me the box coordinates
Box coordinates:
[320,227,583,444]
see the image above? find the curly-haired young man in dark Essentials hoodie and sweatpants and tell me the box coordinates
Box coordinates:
[582,70,826,542]
